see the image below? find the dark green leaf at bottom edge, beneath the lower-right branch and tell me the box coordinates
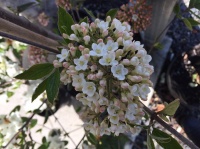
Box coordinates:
[152,128,182,149]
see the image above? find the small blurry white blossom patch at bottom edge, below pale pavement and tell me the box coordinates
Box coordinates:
[47,129,65,149]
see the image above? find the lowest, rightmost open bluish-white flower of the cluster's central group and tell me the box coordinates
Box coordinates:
[111,64,128,80]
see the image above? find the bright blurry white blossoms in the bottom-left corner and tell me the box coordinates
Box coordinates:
[0,112,23,149]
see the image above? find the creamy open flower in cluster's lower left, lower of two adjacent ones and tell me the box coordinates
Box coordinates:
[82,82,96,97]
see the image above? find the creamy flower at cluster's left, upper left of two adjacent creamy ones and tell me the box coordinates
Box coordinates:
[72,73,86,88]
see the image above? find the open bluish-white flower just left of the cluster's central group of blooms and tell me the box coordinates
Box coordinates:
[74,56,88,71]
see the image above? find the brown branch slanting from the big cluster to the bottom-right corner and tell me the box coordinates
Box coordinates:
[144,105,199,149]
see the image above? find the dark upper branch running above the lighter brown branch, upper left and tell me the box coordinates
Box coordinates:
[0,8,63,41]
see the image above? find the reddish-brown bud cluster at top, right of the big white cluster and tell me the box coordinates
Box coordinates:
[117,0,152,33]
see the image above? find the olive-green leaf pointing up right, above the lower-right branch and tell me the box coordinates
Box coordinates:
[158,99,180,116]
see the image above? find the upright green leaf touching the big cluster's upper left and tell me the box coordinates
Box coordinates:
[58,7,74,35]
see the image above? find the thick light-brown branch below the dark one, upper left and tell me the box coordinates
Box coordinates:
[0,18,60,53]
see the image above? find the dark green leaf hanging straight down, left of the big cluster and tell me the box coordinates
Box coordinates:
[46,68,60,104]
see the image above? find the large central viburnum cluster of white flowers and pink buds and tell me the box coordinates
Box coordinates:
[54,16,153,136]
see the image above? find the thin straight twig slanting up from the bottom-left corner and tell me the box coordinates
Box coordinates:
[2,100,46,149]
